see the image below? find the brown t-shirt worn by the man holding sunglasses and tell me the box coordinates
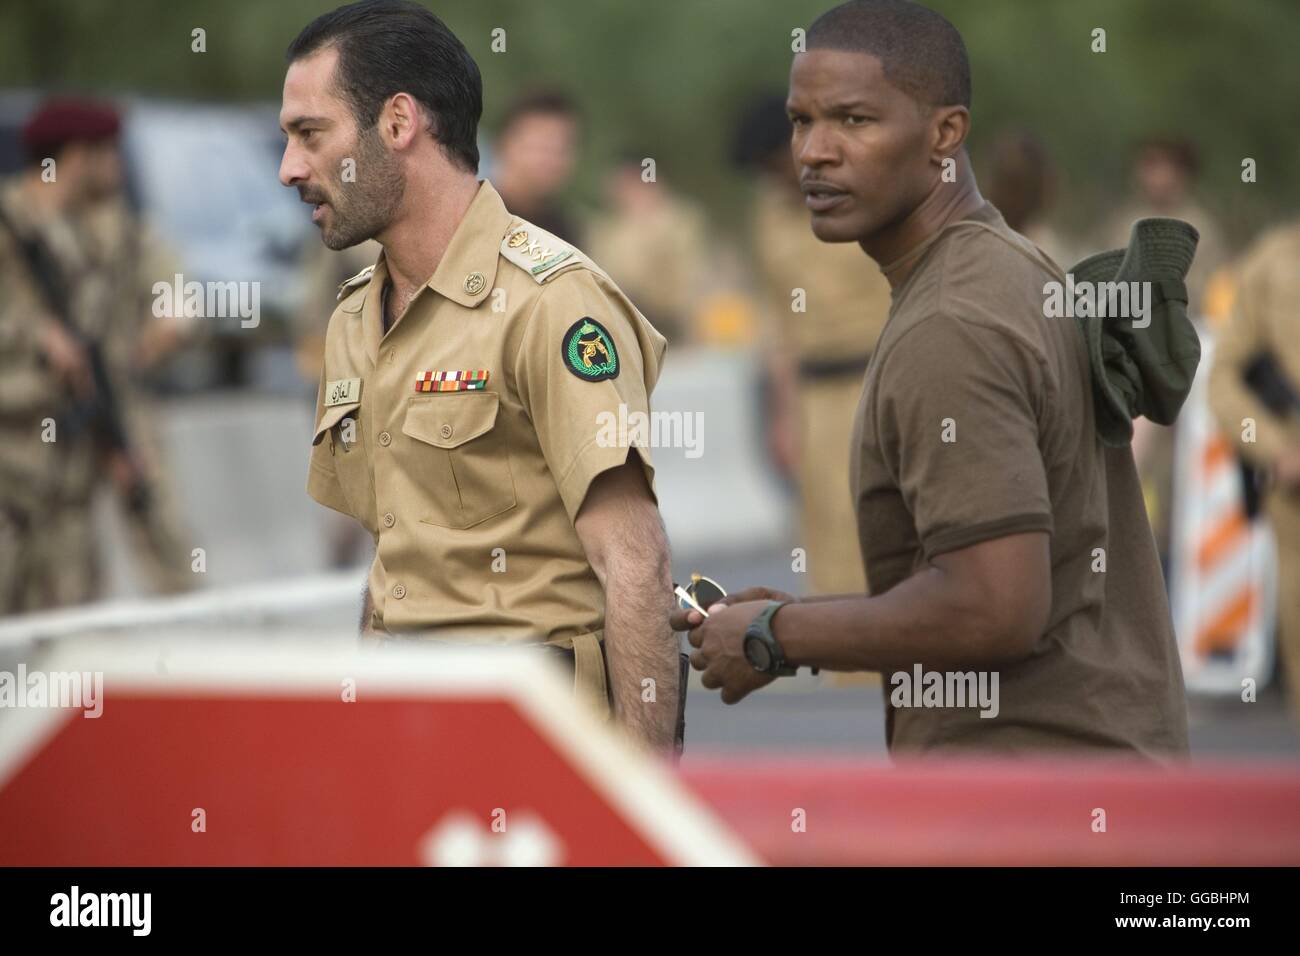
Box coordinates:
[852,204,1187,758]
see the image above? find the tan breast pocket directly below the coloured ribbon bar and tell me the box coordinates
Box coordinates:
[402,392,515,528]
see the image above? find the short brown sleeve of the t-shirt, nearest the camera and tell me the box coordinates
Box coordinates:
[875,315,1052,559]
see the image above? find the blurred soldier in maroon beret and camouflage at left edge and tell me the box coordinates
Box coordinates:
[0,99,125,614]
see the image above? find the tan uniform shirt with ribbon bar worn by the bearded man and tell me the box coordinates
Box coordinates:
[307,182,664,644]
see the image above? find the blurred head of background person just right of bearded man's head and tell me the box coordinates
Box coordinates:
[489,90,582,245]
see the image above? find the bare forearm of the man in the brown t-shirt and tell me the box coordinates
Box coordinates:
[774,567,1021,672]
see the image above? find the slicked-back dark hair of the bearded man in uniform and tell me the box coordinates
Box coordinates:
[285,0,484,172]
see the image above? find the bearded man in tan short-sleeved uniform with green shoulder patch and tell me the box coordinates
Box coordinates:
[281,4,680,749]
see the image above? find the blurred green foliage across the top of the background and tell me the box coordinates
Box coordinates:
[0,0,1300,247]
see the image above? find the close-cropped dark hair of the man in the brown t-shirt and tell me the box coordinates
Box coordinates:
[807,0,971,109]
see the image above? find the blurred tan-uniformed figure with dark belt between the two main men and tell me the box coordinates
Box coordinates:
[733,95,889,606]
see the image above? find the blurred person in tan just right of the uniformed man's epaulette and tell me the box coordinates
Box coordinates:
[586,152,710,342]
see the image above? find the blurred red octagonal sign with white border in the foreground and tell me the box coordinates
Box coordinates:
[0,635,755,866]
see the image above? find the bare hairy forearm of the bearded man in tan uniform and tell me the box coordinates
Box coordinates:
[602,542,681,750]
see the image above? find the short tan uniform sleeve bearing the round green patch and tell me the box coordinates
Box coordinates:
[515,269,664,520]
